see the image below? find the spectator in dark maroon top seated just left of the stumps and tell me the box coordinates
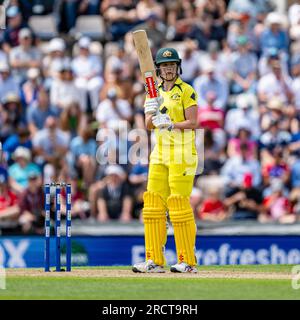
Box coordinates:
[19,171,45,234]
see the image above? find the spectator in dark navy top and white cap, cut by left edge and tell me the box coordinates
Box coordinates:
[0,93,25,141]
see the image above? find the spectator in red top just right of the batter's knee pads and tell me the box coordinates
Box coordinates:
[198,188,227,222]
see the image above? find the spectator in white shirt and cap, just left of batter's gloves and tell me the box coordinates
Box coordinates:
[96,88,132,128]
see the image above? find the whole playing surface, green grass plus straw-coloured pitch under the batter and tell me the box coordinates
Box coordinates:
[0,265,300,300]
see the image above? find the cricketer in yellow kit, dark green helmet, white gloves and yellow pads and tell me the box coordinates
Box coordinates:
[132,48,198,273]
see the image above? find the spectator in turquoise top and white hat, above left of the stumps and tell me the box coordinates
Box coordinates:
[8,146,40,193]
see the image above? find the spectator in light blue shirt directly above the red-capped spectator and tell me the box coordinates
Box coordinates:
[221,144,261,188]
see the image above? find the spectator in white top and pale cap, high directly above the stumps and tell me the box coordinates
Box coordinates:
[50,63,85,111]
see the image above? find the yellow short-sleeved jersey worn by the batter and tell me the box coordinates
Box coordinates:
[151,77,197,163]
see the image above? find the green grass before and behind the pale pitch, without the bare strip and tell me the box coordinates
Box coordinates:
[0,265,300,300]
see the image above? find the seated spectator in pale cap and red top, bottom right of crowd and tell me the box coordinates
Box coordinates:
[259,179,296,223]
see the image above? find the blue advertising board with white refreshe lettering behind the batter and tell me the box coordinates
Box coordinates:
[0,236,300,268]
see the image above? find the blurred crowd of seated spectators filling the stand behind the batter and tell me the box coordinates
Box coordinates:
[0,0,300,233]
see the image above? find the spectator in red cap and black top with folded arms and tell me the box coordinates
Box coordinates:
[224,172,262,220]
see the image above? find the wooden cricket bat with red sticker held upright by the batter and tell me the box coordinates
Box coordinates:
[132,30,159,98]
